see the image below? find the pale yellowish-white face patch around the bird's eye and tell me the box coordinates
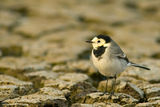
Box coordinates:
[92,37,110,49]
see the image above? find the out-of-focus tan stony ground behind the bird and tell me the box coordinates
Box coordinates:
[0,0,160,106]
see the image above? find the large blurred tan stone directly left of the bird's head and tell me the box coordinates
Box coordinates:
[38,30,91,64]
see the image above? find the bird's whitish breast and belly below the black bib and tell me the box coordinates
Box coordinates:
[92,51,127,76]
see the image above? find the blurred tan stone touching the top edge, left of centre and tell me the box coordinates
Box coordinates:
[27,0,66,17]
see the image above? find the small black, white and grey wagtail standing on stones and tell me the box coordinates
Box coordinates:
[86,35,150,94]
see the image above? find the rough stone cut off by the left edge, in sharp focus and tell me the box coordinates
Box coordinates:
[0,75,34,101]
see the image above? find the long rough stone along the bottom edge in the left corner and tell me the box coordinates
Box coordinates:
[2,88,68,107]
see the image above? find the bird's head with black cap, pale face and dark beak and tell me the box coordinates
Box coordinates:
[86,35,111,49]
